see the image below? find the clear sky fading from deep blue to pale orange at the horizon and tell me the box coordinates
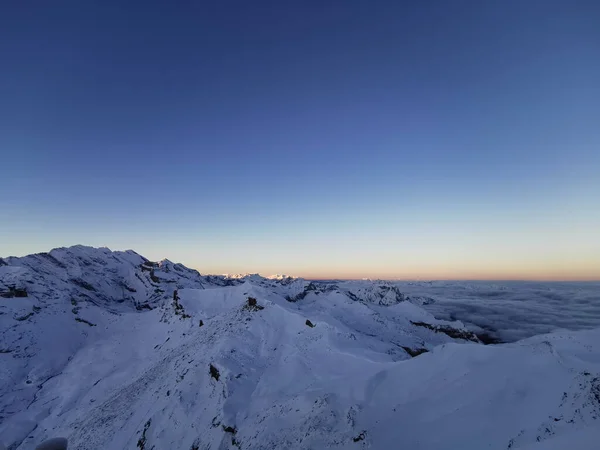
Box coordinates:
[0,0,600,279]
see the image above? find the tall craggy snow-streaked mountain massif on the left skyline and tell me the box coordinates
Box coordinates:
[0,246,186,312]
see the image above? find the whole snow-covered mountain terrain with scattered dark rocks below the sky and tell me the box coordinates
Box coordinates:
[0,246,600,450]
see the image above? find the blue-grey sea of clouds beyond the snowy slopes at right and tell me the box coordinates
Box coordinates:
[398,281,600,342]
